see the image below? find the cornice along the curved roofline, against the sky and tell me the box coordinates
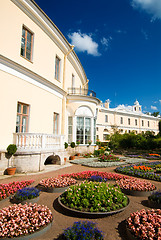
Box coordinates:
[11,0,87,84]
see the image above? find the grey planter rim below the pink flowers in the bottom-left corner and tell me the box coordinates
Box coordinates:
[3,222,52,240]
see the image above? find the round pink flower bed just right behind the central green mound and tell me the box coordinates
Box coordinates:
[116,178,156,196]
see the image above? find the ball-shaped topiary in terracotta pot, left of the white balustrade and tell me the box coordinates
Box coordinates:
[7,144,17,175]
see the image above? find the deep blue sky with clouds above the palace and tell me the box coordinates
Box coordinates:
[36,0,161,113]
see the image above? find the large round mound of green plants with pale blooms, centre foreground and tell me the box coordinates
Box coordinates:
[60,181,128,213]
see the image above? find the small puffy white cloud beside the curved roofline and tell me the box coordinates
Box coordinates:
[68,31,101,56]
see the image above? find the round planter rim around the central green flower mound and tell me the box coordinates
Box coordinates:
[58,195,130,218]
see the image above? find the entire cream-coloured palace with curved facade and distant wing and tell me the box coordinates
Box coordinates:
[0,0,158,174]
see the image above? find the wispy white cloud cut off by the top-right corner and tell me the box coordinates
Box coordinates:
[132,0,161,20]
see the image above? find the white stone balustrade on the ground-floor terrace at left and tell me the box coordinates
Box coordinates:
[14,133,64,151]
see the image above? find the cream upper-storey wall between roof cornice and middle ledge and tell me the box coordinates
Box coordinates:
[0,0,64,87]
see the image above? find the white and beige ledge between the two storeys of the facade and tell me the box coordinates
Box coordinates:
[0,55,66,98]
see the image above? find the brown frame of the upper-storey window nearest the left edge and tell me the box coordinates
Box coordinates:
[20,25,34,62]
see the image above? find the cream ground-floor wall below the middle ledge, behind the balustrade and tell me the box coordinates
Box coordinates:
[0,71,62,149]
